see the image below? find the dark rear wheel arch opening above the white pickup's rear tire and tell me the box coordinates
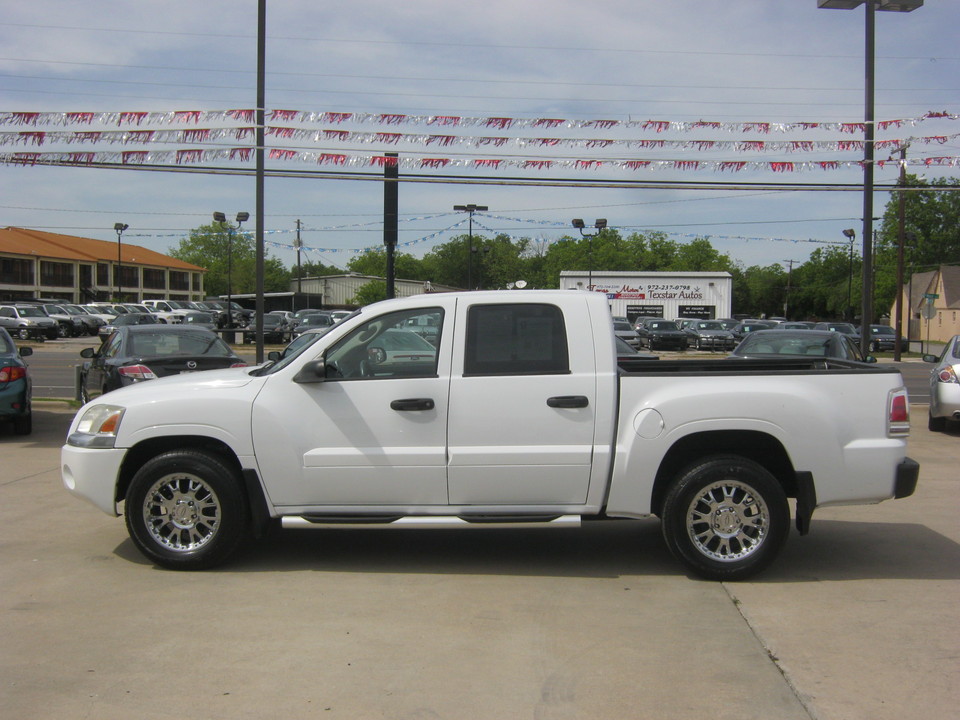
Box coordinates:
[651,430,798,516]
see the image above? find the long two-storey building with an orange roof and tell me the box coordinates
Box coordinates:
[0,227,206,302]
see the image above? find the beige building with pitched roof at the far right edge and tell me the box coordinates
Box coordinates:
[890,265,960,342]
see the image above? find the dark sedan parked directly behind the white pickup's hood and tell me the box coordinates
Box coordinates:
[80,324,246,402]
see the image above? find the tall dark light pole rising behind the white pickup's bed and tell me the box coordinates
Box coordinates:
[817,0,923,355]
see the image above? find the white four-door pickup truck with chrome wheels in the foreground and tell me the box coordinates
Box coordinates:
[61,291,919,579]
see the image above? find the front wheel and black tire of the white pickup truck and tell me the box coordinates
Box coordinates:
[124,450,249,570]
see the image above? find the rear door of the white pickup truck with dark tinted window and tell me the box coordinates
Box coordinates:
[447,293,597,505]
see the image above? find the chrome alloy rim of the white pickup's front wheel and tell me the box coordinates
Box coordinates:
[143,472,220,553]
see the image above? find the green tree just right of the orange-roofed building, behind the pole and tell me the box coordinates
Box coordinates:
[168,223,290,296]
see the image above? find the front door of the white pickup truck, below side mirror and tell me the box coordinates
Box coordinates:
[253,303,452,512]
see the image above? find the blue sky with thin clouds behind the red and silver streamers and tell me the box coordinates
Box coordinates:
[0,0,960,276]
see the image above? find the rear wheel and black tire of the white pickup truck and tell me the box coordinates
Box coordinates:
[661,455,790,580]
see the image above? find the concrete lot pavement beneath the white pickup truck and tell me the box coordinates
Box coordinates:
[0,403,960,720]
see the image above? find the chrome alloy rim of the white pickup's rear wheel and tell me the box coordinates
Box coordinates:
[686,480,770,562]
